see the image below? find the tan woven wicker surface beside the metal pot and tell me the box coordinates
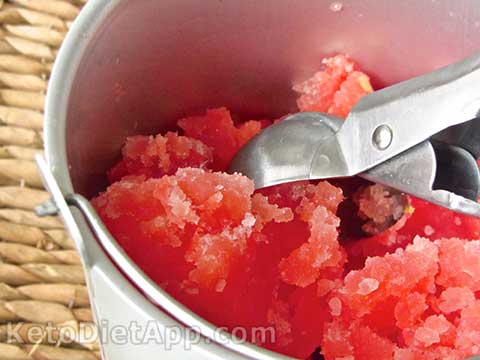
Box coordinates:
[0,0,100,360]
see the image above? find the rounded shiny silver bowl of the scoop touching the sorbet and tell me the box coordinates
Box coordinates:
[230,113,348,189]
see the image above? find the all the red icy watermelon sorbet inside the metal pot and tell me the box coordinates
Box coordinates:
[92,55,480,360]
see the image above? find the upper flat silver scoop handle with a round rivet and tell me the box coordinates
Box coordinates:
[337,53,480,175]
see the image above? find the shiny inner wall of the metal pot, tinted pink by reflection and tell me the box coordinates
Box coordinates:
[66,0,480,196]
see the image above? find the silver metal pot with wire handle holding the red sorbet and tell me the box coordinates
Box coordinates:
[39,0,480,360]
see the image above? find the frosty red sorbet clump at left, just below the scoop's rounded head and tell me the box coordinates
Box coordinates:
[94,168,260,288]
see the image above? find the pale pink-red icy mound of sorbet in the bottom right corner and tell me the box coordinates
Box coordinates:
[322,237,480,360]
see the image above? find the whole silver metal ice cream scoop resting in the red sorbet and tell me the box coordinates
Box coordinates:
[230,54,480,217]
